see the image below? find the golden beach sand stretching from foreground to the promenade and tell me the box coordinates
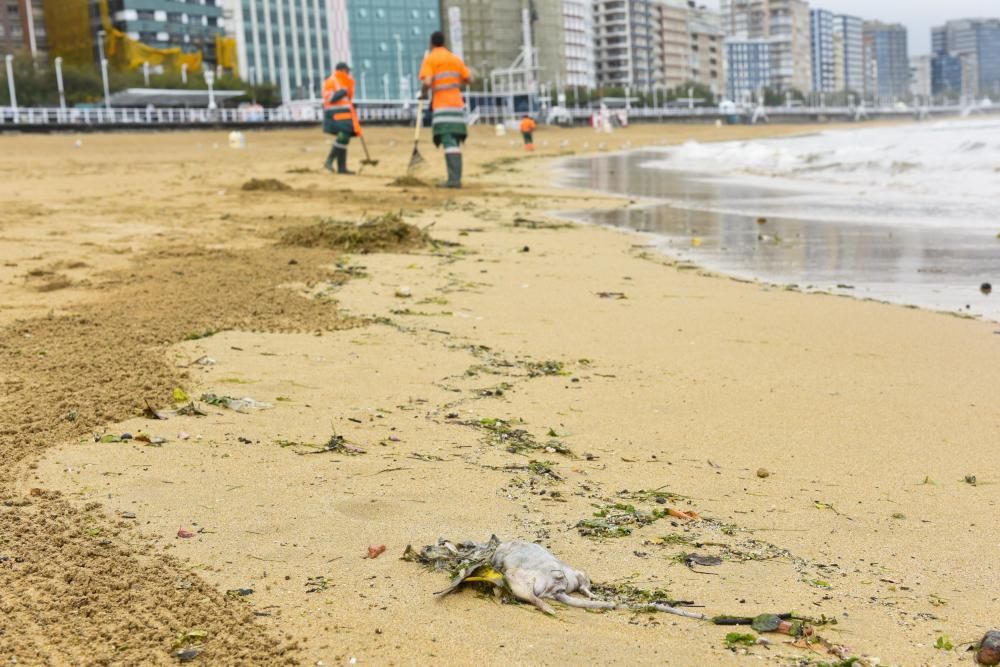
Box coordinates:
[0,126,1000,665]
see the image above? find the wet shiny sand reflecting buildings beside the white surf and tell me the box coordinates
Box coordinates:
[562,151,1000,321]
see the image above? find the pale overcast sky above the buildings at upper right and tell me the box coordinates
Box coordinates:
[702,0,1000,56]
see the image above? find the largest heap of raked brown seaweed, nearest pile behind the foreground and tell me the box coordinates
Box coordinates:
[281,213,432,255]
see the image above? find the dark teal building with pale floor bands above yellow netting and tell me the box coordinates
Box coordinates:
[108,0,224,57]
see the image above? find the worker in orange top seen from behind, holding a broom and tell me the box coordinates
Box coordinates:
[420,31,472,188]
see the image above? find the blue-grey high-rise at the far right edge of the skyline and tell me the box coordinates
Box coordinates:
[931,19,1000,95]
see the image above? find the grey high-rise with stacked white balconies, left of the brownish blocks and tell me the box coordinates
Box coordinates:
[594,0,663,90]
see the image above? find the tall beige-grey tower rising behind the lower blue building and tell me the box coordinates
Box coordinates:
[720,0,812,91]
